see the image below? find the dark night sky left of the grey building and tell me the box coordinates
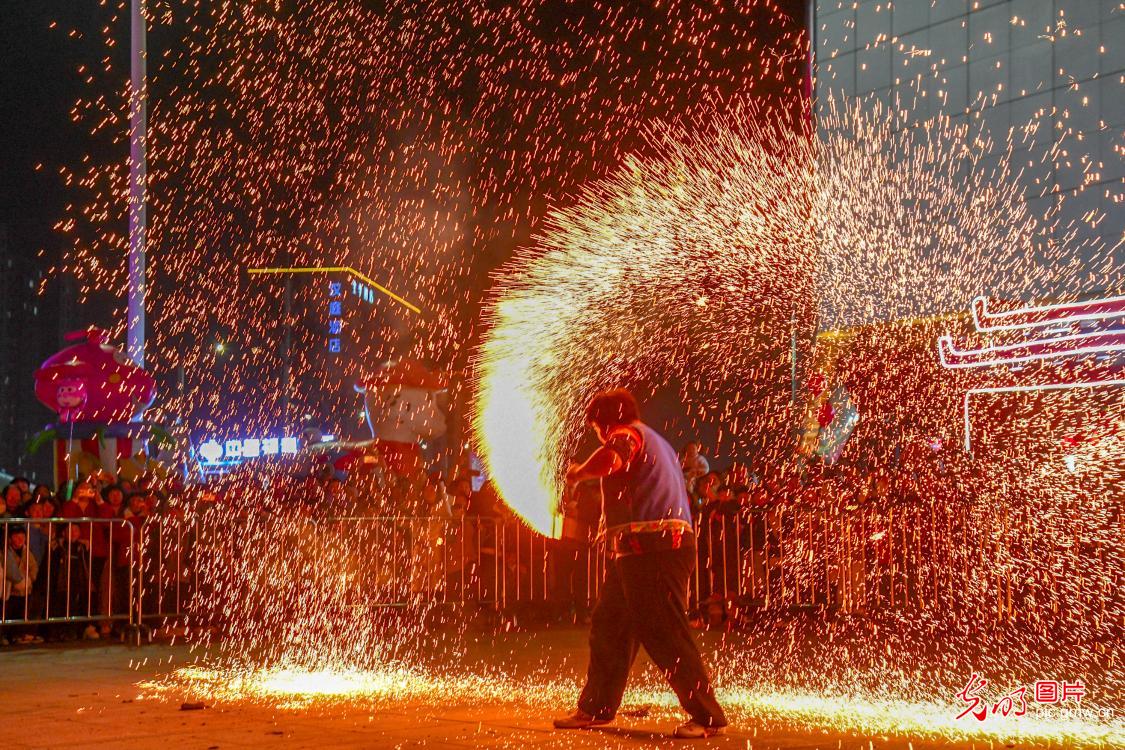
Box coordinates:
[0,0,807,479]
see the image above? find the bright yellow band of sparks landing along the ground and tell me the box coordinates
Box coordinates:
[141,665,1125,748]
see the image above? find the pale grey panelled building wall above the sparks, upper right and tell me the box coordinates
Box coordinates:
[811,0,1125,302]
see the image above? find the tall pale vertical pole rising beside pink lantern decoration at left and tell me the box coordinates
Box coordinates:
[126,0,147,368]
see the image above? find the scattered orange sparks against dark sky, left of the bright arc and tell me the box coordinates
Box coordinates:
[48,0,804,433]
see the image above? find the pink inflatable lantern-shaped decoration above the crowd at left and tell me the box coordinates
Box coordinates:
[35,327,156,423]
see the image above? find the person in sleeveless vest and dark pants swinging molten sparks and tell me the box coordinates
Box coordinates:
[555,389,727,739]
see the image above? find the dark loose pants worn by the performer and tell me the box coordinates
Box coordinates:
[578,544,727,726]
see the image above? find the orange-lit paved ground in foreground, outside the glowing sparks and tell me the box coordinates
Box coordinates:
[0,632,1080,750]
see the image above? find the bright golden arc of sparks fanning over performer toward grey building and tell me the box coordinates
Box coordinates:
[476,91,1121,534]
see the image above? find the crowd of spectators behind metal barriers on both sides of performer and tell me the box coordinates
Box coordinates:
[0,442,985,643]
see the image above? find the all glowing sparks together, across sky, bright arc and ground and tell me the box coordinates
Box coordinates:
[50,0,1125,747]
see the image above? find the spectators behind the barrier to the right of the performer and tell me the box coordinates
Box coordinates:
[666,442,974,626]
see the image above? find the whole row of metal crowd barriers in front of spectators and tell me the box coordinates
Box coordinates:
[0,503,1060,631]
